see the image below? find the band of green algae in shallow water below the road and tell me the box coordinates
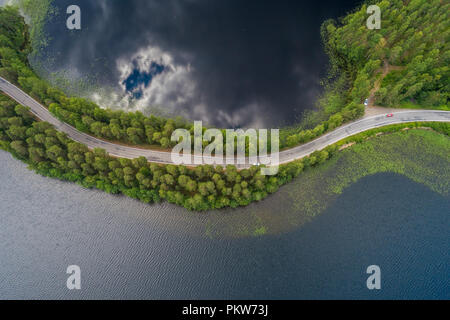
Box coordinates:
[202,129,450,237]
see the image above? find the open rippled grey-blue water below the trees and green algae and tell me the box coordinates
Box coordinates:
[0,152,450,299]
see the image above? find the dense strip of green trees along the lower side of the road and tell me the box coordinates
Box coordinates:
[0,95,337,210]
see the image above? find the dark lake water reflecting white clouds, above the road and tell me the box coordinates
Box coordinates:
[39,0,362,127]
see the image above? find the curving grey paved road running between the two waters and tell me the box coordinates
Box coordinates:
[0,77,450,168]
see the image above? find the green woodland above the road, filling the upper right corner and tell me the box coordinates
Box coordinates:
[281,0,450,146]
